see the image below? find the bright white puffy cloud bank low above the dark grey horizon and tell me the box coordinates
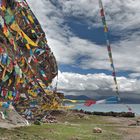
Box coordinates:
[51,71,140,93]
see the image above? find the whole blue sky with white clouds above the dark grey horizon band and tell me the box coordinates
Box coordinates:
[28,0,140,99]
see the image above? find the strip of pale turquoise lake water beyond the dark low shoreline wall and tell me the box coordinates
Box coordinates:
[74,104,140,116]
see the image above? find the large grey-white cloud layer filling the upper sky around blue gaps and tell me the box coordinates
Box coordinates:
[28,0,140,72]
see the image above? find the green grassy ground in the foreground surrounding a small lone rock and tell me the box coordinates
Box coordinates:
[0,111,122,140]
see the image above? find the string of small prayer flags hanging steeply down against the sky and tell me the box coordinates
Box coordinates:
[99,0,119,96]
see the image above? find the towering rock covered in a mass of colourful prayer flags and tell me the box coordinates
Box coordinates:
[0,0,60,119]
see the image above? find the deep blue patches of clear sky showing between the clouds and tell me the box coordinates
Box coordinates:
[59,17,132,77]
